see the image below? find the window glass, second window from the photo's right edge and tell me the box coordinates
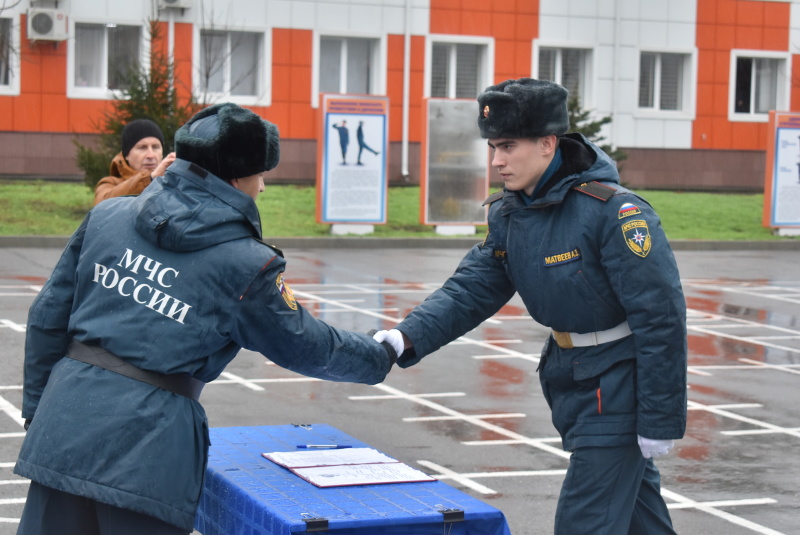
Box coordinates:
[639,52,690,111]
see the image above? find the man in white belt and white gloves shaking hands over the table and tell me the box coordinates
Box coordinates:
[375,78,687,535]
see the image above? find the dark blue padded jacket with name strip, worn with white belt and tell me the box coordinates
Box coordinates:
[398,134,687,451]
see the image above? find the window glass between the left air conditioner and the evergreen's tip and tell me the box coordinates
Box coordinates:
[74,24,141,90]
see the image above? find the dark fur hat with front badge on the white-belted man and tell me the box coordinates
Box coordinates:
[478,78,569,139]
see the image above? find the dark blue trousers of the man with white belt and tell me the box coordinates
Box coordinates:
[555,443,675,535]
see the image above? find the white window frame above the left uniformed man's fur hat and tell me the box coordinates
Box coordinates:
[192,25,272,106]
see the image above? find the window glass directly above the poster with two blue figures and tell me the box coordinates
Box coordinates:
[319,37,379,95]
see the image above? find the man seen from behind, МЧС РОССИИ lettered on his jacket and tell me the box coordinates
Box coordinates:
[14,103,396,535]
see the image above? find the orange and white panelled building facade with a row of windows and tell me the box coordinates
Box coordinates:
[0,0,800,190]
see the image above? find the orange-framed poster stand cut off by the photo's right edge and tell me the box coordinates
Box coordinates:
[763,111,800,234]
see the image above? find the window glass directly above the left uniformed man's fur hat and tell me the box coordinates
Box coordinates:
[199,30,263,97]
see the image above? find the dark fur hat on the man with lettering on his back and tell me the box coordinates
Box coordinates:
[175,102,280,180]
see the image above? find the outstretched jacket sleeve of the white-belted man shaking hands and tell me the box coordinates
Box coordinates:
[397,226,515,368]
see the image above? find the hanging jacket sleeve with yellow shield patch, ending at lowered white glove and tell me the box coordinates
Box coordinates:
[601,195,687,439]
